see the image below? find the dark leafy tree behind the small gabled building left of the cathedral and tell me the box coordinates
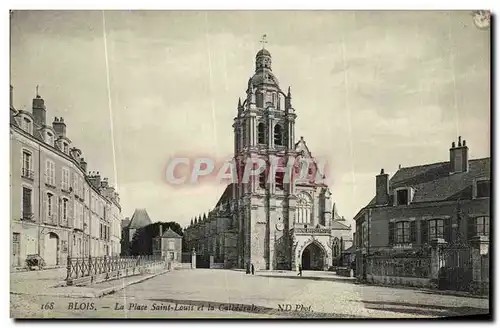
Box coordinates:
[130,221,183,256]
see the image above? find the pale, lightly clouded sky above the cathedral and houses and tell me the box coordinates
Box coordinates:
[11,11,490,229]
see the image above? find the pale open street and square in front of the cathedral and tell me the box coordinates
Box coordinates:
[11,269,489,318]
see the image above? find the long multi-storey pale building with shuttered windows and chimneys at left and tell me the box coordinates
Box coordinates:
[10,86,121,267]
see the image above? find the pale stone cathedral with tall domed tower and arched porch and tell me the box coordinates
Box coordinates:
[184,47,352,270]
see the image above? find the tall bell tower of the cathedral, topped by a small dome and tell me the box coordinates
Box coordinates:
[233,39,296,269]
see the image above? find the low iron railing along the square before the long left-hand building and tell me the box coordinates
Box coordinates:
[66,255,164,282]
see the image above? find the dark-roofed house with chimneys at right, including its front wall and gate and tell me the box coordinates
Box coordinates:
[354,137,491,289]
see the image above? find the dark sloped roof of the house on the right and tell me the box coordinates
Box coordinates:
[368,157,491,206]
